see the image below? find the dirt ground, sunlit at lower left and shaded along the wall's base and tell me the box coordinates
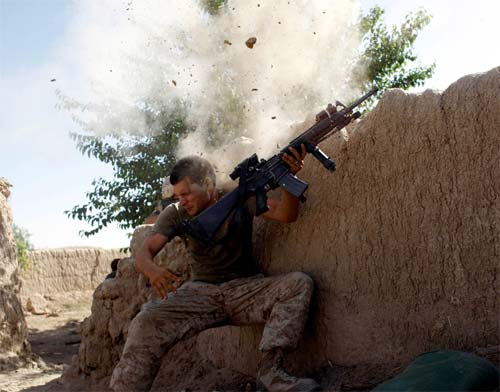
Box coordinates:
[0,292,498,392]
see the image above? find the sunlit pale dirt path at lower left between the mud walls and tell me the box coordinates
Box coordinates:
[0,292,92,392]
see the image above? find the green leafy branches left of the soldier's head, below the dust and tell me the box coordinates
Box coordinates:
[65,111,188,237]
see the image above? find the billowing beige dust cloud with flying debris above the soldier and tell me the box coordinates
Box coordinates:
[65,0,360,182]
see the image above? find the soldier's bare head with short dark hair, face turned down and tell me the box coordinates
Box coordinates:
[170,155,216,216]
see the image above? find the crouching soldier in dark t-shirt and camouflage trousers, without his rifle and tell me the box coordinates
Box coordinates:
[110,146,319,391]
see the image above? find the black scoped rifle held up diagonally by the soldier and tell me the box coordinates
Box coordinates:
[181,88,378,245]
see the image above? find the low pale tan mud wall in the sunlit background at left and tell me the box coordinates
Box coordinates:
[21,248,128,298]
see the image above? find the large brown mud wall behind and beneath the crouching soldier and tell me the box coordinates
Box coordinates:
[67,68,500,389]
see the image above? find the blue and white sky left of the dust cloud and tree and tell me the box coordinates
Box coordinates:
[0,0,120,248]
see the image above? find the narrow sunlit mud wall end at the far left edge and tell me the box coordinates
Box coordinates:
[0,177,31,370]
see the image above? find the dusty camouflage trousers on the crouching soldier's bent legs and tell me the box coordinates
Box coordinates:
[110,272,313,391]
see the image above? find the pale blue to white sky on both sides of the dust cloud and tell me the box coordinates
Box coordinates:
[0,0,500,248]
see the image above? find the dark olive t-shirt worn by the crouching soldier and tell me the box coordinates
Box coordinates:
[152,198,258,283]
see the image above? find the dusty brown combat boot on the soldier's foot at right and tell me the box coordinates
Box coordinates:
[257,349,320,392]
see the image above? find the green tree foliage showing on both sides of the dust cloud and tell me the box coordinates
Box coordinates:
[63,4,435,237]
